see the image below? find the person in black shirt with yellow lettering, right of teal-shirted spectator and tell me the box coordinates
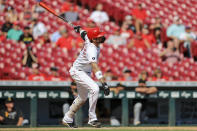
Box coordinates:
[19,26,34,45]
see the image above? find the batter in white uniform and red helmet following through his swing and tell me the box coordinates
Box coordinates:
[62,26,110,128]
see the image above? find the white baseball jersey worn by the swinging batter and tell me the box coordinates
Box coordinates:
[73,35,100,73]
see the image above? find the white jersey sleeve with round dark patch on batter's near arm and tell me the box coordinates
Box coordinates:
[86,47,97,63]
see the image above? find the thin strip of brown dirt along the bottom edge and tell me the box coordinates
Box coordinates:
[0,126,197,131]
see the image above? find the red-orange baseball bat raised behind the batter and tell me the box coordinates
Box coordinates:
[37,0,75,27]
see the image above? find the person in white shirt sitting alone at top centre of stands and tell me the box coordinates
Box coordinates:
[90,4,109,25]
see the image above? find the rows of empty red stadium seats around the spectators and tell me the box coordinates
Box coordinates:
[0,0,197,81]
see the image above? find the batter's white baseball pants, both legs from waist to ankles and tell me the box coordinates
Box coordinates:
[66,67,99,122]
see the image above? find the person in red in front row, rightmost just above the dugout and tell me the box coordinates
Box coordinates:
[152,68,168,81]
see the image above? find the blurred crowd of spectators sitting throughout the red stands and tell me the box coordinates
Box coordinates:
[0,0,197,81]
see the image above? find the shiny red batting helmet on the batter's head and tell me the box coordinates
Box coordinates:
[85,27,105,40]
